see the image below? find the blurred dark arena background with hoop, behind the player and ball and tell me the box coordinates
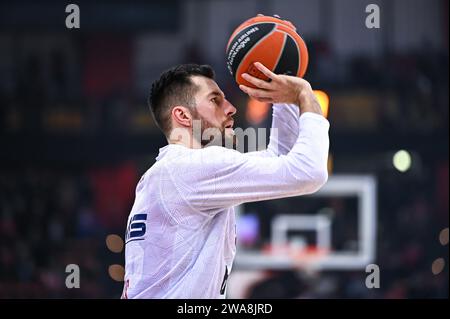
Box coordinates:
[0,0,449,298]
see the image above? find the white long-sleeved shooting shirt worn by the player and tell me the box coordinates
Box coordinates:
[122,104,329,298]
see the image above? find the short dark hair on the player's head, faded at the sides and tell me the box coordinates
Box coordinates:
[148,64,214,136]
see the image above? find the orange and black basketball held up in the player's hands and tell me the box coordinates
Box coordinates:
[226,16,308,87]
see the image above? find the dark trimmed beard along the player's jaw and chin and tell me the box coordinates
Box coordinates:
[193,111,237,149]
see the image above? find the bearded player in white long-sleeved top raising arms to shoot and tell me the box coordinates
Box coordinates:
[122,63,329,299]
